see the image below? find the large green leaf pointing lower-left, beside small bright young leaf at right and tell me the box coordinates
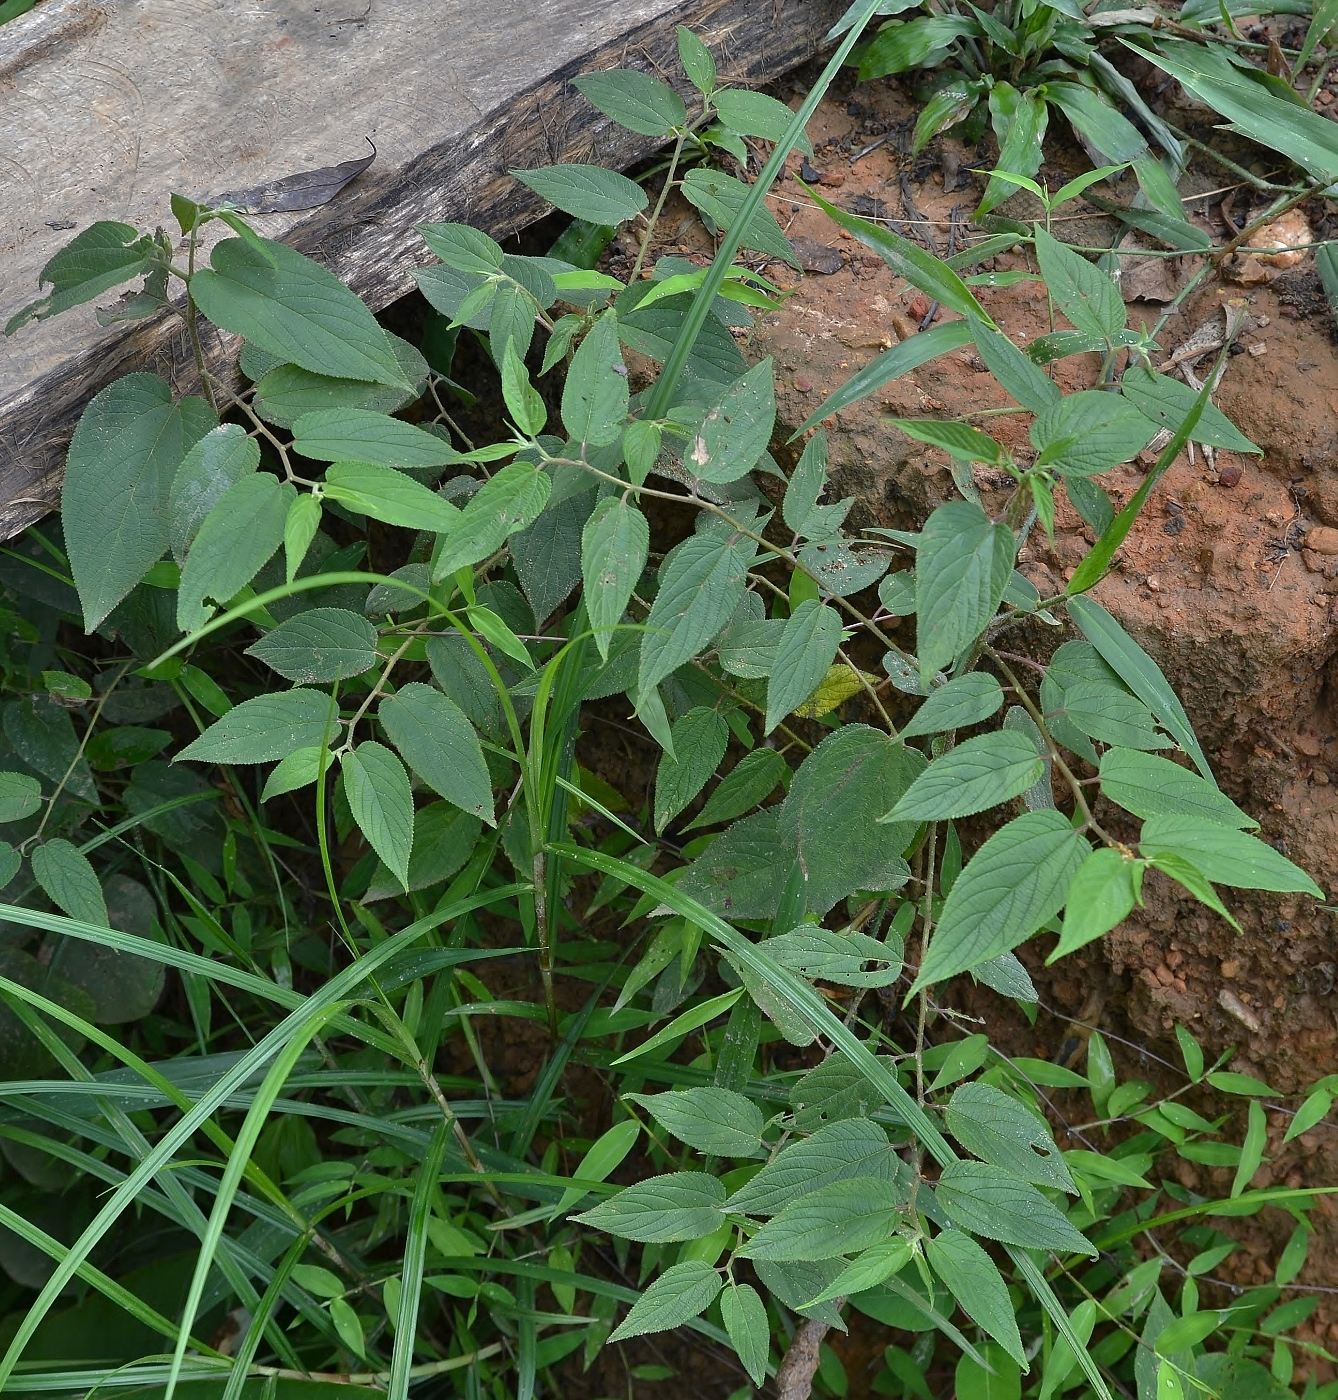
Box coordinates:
[911,811,1089,991]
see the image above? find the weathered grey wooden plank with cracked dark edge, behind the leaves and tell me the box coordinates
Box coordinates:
[0,0,844,539]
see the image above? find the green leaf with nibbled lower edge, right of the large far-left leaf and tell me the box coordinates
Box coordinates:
[176,472,297,633]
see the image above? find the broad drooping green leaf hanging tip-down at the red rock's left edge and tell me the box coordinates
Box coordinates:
[915,501,1015,683]
